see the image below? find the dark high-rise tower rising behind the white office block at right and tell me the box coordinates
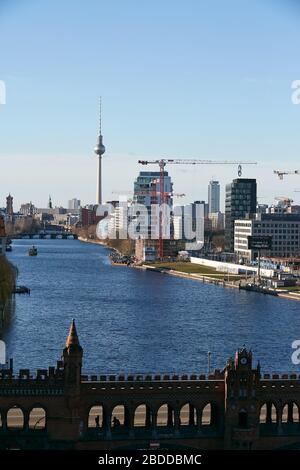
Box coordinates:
[225,178,257,253]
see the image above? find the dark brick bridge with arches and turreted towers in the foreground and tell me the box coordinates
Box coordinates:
[0,321,300,450]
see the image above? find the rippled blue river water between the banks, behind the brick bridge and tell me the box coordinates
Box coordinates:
[2,240,300,374]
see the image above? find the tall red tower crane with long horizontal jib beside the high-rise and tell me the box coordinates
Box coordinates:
[138,158,257,258]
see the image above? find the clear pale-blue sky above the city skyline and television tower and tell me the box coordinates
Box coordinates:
[0,0,300,206]
